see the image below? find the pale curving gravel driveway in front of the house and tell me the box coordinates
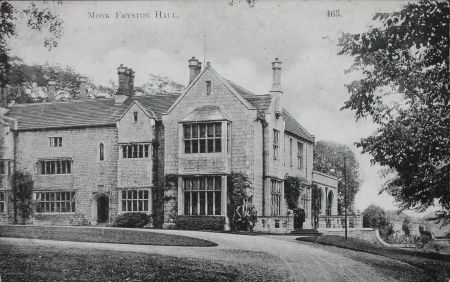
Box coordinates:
[0,230,428,281]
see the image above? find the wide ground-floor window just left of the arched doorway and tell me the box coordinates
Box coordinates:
[33,190,77,214]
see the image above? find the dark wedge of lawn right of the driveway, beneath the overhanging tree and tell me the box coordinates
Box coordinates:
[297,235,450,280]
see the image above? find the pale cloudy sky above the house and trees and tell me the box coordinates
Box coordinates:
[9,0,414,210]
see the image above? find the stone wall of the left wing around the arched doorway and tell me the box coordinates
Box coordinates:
[16,127,118,224]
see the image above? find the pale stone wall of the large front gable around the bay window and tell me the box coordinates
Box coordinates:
[163,66,262,220]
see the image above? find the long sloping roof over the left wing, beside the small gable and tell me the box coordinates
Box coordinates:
[6,94,178,130]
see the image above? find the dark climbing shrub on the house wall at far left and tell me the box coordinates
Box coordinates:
[12,170,34,224]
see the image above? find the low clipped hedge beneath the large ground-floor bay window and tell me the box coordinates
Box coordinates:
[175,215,225,231]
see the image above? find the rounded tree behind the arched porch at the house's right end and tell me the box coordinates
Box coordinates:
[313,140,360,214]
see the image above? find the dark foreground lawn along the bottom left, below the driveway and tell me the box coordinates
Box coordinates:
[0,242,283,281]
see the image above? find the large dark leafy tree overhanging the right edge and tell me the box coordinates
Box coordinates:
[339,1,450,214]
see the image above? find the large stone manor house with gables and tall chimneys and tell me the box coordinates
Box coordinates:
[0,57,338,232]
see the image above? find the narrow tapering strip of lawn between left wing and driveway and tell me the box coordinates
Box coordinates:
[0,225,217,247]
